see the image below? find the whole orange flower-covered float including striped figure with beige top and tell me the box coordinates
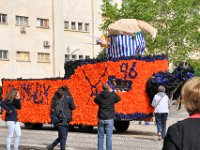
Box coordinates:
[2,19,183,131]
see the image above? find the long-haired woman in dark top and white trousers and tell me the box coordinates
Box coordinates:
[1,88,21,150]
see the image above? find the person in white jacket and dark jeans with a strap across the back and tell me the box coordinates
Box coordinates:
[151,85,169,140]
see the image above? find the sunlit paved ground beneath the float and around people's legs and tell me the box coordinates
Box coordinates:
[0,104,187,150]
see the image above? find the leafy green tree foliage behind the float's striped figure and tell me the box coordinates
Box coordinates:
[100,0,200,63]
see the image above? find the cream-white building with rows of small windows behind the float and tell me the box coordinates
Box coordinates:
[0,0,122,84]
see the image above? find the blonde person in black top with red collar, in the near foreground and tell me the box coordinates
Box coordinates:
[162,77,200,150]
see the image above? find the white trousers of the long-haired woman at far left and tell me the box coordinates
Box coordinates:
[6,121,22,150]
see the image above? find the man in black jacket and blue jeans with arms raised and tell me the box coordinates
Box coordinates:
[94,83,120,150]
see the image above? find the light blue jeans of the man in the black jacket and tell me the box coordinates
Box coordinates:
[98,119,114,150]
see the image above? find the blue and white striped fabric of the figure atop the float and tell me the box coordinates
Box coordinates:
[106,33,145,58]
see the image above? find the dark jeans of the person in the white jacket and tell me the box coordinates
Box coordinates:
[155,113,168,139]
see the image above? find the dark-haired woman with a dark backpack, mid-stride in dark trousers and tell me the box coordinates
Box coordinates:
[47,89,68,150]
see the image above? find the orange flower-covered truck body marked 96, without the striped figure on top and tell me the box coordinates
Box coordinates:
[2,55,168,131]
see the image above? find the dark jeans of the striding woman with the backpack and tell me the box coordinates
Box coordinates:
[51,125,68,150]
